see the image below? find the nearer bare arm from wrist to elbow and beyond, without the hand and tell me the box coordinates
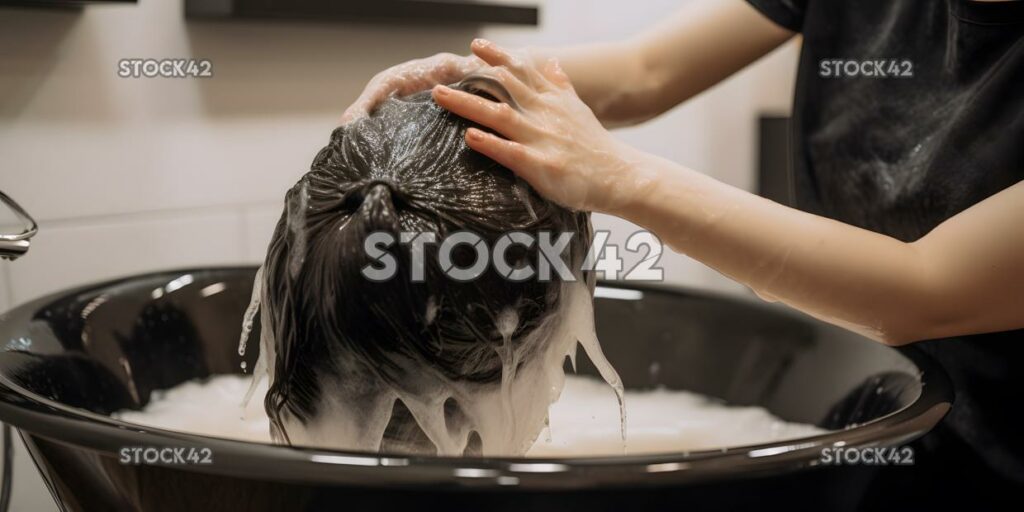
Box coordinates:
[611,149,1024,344]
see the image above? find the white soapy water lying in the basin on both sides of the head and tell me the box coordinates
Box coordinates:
[115,375,824,457]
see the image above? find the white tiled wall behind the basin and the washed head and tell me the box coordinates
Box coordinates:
[0,0,797,510]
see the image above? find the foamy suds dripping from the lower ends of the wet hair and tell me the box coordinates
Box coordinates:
[239,271,627,456]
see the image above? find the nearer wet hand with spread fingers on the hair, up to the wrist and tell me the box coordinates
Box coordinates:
[434,40,643,213]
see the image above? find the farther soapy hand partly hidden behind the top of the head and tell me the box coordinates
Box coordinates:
[341,53,485,125]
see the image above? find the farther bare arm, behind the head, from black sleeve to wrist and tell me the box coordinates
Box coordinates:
[548,0,794,126]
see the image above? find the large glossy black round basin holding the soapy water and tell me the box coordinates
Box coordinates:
[0,268,951,511]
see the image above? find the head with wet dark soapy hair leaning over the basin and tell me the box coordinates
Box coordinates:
[256,79,593,451]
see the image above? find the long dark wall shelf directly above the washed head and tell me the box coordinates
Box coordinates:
[185,0,539,26]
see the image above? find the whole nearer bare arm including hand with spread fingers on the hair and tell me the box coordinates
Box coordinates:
[434,38,1024,345]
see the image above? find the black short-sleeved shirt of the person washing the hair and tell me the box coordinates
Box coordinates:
[750,0,1024,505]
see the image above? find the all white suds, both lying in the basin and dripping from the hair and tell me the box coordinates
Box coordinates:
[140,268,821,457]
